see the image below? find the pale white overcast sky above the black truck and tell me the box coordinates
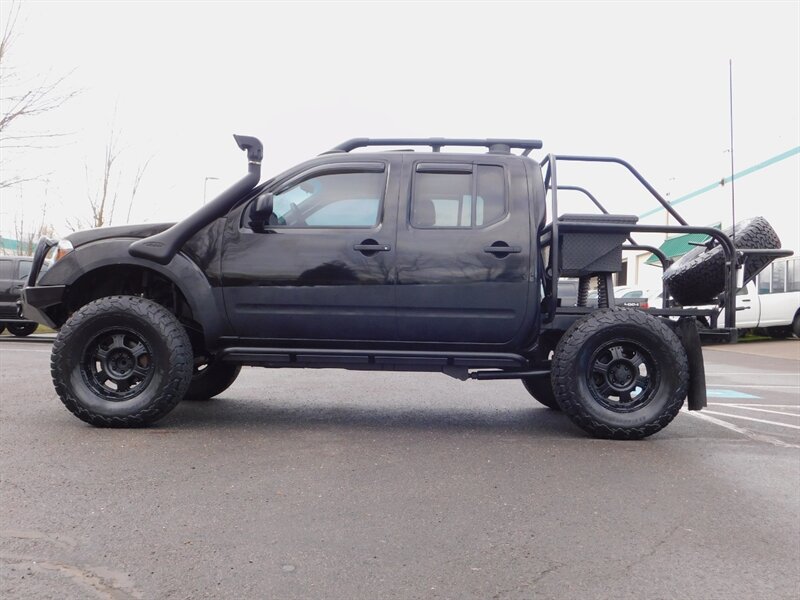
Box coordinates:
[0,0,800,235]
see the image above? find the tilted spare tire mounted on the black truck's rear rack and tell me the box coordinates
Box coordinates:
[663,217,781,306]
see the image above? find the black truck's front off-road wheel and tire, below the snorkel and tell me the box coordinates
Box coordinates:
[50,296,193,427]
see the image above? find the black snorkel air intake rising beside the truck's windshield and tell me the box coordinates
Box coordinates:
[128,135,264,265]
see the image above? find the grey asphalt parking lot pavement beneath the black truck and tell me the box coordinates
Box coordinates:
[0,336,800,599]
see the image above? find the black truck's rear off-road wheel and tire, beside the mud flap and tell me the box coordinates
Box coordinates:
[552,308,689,440]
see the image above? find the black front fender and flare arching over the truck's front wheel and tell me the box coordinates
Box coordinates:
[37,237,230,350]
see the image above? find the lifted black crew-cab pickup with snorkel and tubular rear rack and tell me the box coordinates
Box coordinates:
[23,136,786,439]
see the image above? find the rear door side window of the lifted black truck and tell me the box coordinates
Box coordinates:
[410,163,508,229]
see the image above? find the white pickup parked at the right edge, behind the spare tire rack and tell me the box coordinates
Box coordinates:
[718,257,800,338]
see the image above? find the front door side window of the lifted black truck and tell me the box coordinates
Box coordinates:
[273,173,385,228]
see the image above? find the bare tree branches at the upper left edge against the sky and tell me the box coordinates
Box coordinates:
[0,1,77,189]
